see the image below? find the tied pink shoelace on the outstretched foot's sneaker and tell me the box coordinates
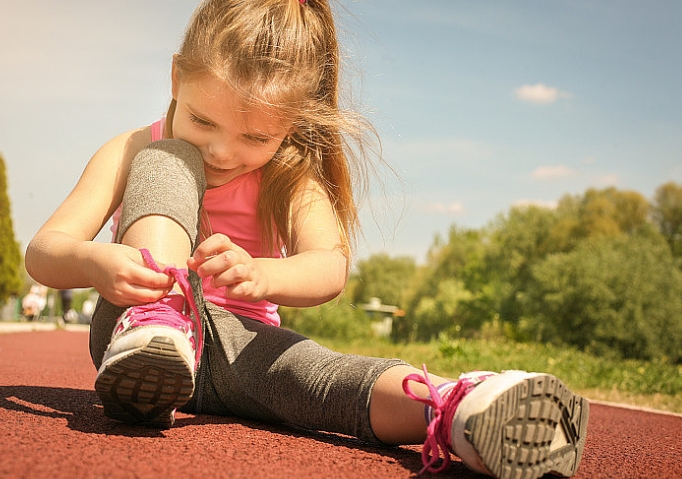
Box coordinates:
[403,365,490,474]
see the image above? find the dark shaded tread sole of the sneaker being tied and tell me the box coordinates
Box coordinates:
[95,336,194,429]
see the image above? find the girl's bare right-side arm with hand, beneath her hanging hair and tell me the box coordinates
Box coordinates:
[188,180,348,307]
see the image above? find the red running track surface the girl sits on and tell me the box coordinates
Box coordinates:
[0,331,682,479]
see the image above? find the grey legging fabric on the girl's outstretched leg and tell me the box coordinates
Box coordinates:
[183,302,404,443]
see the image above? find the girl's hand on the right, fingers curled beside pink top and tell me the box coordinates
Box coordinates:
[187,233,268,301]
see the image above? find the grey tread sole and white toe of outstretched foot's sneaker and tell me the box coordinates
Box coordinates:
[453,372,589,479]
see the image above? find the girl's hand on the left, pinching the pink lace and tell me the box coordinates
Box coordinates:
[88,243,175,306]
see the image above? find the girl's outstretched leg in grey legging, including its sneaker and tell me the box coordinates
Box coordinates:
[183,290,589,478]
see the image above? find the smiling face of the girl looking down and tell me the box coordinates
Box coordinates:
[172,66,291,188]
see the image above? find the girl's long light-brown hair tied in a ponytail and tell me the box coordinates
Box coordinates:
[166,0,373,256]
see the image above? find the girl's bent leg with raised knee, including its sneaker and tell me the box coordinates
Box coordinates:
[91,140,205,427]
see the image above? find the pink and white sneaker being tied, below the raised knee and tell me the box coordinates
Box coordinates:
[95,250,203,428]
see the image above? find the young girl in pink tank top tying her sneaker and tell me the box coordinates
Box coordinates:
[26,0,588,478]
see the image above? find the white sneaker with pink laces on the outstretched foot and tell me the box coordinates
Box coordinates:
[403,368,589,479]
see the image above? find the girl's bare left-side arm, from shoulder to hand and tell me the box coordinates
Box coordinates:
[26,128,175,306]
